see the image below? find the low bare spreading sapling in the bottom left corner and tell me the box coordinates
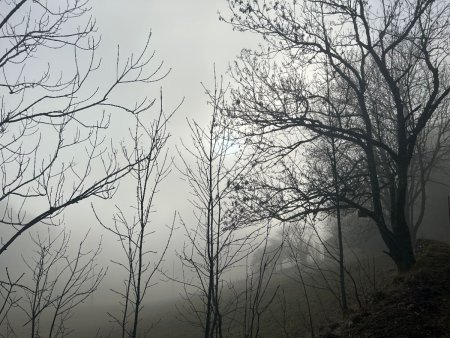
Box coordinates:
[0,229,106,338]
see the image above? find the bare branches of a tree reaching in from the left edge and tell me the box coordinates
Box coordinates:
[0,0,167,254]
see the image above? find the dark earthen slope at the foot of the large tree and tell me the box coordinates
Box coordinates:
[320,240,450,338]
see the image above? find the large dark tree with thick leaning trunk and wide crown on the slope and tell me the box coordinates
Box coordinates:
[224,0,450,271]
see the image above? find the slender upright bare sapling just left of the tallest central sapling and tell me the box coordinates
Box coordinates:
[92,91,178,338]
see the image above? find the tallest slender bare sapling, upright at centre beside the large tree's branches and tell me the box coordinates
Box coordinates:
[179,72,259,338]
